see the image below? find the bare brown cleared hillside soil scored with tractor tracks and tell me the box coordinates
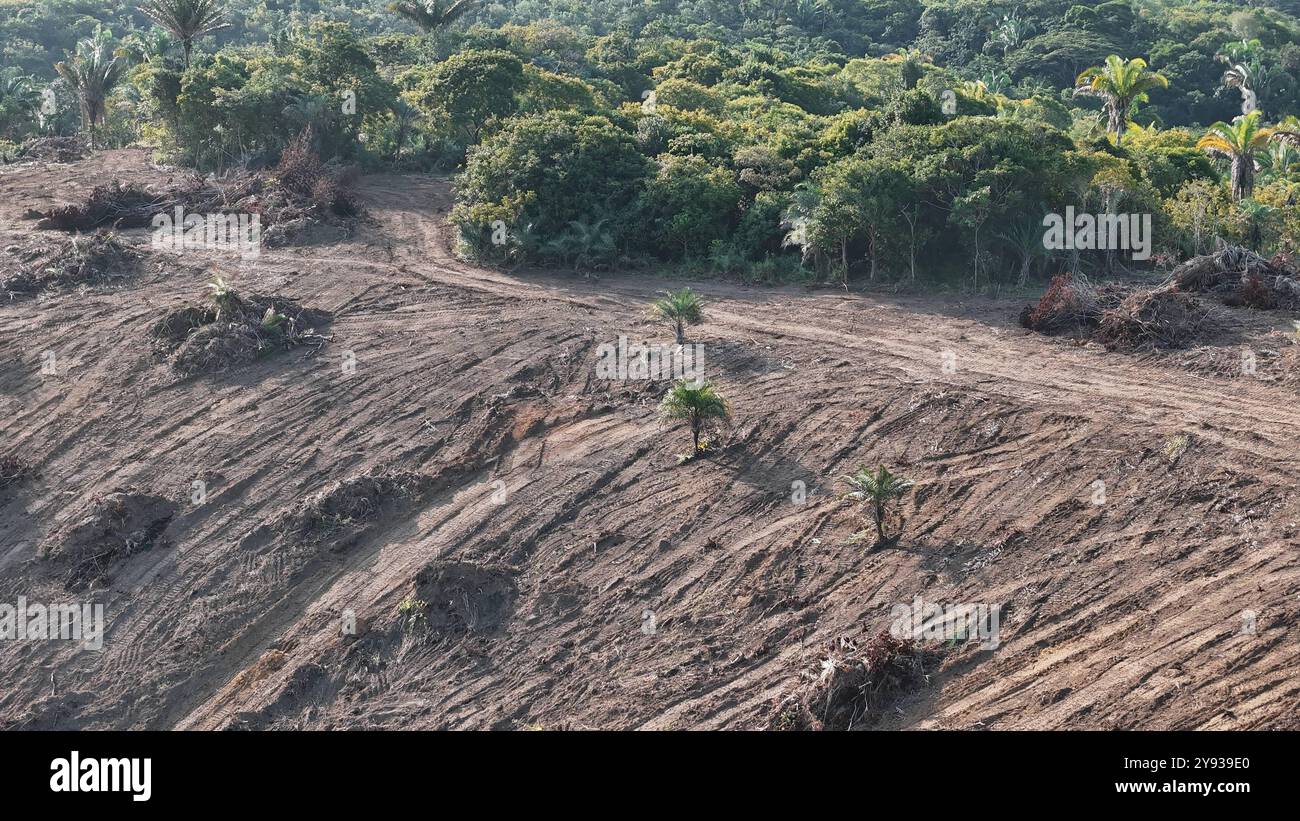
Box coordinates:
[0,151,1300,729]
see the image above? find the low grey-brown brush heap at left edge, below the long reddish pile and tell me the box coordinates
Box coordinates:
[0,229,140,299]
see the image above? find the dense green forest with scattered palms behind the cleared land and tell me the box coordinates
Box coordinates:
[0,0,1300,288]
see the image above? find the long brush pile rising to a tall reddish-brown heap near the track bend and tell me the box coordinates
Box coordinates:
[36,130,361,244]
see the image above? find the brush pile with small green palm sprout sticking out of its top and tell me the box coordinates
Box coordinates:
[151,277,332,377]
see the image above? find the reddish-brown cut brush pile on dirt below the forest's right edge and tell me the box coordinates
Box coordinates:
[1021,273,1213,349]
